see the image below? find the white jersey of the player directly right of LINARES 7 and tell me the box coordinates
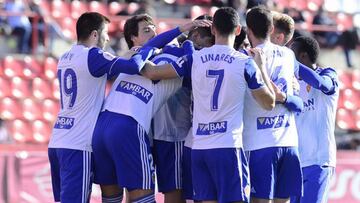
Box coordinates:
[244,42,298,151]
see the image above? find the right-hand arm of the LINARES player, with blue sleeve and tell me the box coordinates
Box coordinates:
[248,49,275,110]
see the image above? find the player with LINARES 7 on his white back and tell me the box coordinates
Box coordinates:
[144,7,275,202]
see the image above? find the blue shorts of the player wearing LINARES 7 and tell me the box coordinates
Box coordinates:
[191,148,250,202]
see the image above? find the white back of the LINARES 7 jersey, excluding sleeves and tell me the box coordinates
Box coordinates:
[191,45,249,149]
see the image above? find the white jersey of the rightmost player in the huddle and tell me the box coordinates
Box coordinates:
[296,68,339,167]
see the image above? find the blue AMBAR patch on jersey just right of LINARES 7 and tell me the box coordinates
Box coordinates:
[257,115,290,130]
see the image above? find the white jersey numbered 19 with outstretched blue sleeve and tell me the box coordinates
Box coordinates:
[49,45,152,151]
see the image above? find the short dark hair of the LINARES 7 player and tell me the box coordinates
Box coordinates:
[213,7,240,35]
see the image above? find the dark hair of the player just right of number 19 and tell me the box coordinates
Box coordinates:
[124,13,155,49]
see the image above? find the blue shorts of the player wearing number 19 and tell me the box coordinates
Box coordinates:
[48,148,93,203]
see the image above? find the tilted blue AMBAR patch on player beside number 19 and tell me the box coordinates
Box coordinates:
[116,81,153,104]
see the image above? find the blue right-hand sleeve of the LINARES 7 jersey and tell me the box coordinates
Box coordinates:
[244,59,264,90]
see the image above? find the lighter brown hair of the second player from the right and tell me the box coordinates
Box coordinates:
[273,12,295,43]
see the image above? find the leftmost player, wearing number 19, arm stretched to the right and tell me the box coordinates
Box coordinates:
[48,12,153,202]
